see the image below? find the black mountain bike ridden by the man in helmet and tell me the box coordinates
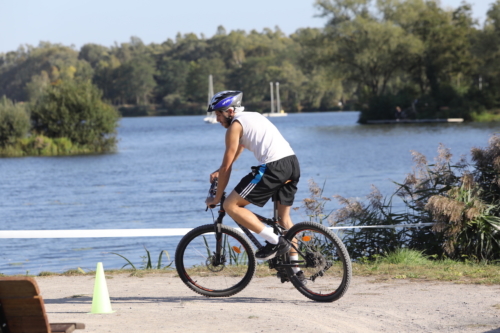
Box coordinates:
[175,181,352,302]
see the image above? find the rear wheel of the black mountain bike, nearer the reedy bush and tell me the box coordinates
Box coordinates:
[285,222,352,302]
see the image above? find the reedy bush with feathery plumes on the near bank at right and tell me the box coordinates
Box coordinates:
[335,136,500,261]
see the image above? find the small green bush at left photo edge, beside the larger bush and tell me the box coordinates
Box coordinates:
[0,96,31,147]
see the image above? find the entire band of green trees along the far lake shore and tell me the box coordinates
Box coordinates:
[0,0,500,121]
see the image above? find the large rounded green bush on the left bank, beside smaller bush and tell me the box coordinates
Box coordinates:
[31,81,119,151]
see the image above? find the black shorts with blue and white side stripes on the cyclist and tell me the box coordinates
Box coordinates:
[234,155,300,207]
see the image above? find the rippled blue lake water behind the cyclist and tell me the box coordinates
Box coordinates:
[0,112,499,274]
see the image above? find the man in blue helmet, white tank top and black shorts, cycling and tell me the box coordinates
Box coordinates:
[206,90,300,264]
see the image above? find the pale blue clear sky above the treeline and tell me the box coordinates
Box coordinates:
[0,0,495,53]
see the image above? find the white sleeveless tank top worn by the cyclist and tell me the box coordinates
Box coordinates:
[233,111,295,164]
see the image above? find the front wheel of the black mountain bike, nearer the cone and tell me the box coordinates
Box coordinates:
[175,224,255,297]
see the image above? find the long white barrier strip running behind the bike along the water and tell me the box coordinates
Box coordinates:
[0,223,434,238]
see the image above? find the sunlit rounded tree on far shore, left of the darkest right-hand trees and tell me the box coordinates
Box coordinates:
[317,0,423,97]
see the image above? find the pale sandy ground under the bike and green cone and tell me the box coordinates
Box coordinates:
[36,274,500,333]
